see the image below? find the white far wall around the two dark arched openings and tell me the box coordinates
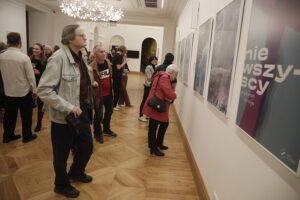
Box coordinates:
[104,24,164,72]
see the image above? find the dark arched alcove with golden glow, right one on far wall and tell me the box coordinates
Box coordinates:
[140,38,157,73]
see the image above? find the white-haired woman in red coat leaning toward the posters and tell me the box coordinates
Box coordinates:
[143,64,178,156]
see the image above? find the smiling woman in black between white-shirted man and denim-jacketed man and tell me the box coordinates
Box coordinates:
[30,43,46,132]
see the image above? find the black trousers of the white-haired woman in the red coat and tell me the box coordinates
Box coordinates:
[148,118,169,148]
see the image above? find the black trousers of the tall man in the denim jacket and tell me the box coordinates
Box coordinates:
[51,106,93,187]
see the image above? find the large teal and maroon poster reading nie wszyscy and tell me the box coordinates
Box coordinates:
[236,0,300,176]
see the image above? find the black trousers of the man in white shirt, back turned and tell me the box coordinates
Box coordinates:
[3,92,32,140]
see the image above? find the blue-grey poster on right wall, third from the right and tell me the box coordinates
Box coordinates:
[194,18,213,96]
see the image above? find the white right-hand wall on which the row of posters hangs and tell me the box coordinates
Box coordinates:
[175,0,300,200]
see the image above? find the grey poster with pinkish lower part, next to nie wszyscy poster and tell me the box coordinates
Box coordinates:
[207,0,244,114]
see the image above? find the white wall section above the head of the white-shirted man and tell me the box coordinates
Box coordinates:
[0,0,27,53]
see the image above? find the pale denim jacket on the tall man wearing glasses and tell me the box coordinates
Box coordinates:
[37,46,92,124]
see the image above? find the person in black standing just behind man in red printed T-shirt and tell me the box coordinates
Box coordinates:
[112,46,127,110]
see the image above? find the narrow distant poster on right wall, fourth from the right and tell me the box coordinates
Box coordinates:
[183,33,194,85]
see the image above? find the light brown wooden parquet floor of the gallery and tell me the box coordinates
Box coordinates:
[0,73,198,200]
